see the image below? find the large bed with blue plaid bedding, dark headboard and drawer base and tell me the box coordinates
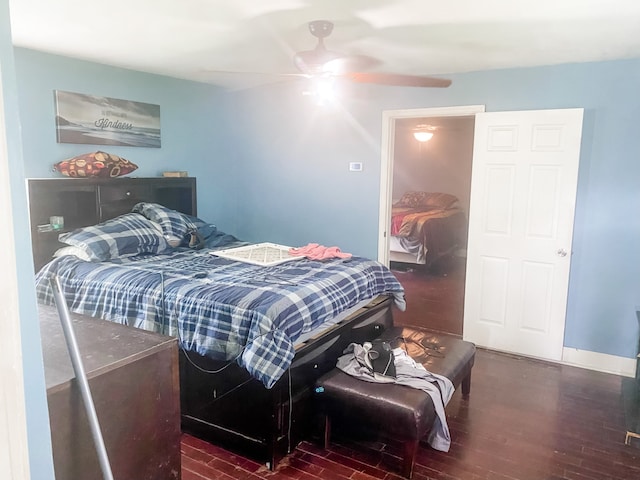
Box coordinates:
[30,179,404,468]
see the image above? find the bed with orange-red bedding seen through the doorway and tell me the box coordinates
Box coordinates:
[389,191,467,268]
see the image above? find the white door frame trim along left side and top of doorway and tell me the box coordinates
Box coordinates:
[378,105,485,267]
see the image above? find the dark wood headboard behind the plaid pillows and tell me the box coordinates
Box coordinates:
[27,177,198,270]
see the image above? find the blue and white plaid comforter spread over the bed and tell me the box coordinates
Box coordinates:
[36,250,405,388]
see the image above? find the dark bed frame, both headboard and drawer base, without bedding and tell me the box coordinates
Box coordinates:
[28,177,393,469]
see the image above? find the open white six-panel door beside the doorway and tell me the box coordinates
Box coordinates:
[464,109,583,360]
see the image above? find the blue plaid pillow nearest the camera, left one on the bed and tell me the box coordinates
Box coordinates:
[58,213,171,262]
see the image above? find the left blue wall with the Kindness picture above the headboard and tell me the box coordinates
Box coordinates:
[15,48,245,235]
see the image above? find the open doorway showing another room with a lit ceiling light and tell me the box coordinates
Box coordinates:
[379,106,484,336]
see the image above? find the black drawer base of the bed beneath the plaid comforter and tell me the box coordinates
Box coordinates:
[180,297,393,469]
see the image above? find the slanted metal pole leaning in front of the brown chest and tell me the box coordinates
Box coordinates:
[50,275,113,480]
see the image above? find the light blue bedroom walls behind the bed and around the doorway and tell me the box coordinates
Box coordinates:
[16,49,640,370]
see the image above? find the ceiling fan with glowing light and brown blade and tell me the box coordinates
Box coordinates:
[293,20,451,88]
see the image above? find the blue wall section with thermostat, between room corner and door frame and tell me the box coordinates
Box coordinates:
[228,82,382,258]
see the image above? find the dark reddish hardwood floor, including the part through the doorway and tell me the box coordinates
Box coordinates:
[182,258,640,480]
